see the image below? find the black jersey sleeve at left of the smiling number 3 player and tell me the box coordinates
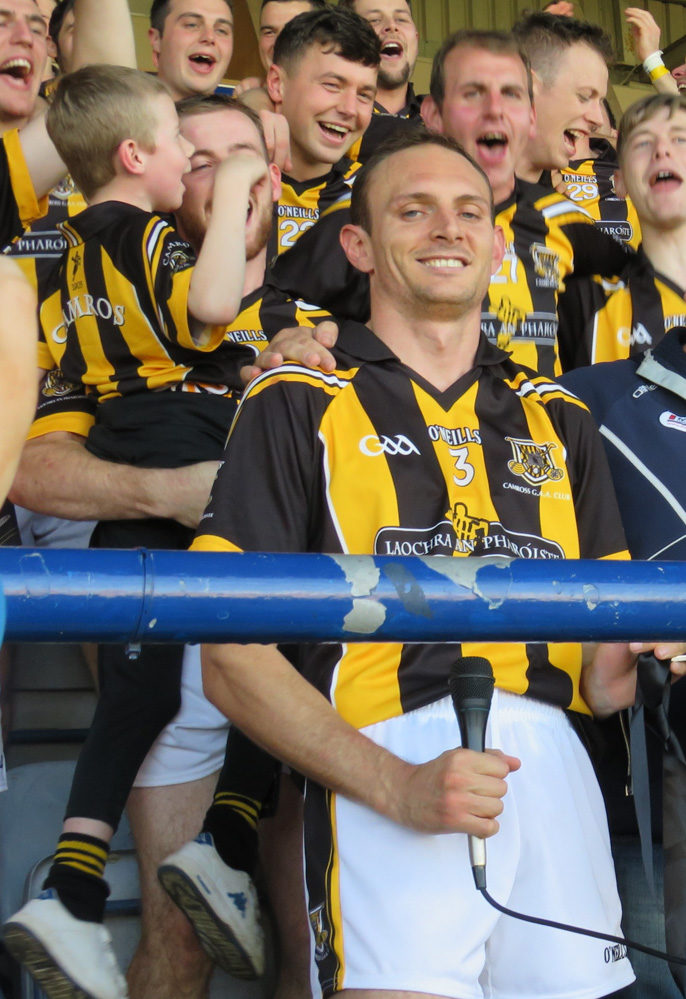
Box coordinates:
[192,372,328,552]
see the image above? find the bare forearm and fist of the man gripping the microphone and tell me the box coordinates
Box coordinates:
[203,645,519,836]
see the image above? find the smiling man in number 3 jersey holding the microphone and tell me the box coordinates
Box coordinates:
[188,129,672,999]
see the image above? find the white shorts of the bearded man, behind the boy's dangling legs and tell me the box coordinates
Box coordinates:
[134,645,229,787]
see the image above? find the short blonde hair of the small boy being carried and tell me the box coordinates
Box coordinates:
[46,66,169,199]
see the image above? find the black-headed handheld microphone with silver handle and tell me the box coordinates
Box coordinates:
[448,656,495,891]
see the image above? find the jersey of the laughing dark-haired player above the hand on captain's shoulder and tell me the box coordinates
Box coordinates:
[268,156,361,257]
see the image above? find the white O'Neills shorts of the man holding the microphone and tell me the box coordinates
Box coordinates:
[305,690,634,999]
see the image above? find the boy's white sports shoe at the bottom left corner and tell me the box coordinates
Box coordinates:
[4,888,129,999]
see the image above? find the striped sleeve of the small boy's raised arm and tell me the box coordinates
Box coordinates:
[142,216,226,351]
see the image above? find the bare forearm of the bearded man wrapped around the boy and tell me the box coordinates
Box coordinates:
[10,433,216,527]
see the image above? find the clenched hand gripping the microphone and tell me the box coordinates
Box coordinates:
[391,749,521,839]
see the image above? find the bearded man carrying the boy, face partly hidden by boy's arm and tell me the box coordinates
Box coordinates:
[5,96,328,999]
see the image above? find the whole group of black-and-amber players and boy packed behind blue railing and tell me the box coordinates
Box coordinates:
[0,0,686,999]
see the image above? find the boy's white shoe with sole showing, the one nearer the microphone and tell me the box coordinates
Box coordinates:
[157,833,265,979]
